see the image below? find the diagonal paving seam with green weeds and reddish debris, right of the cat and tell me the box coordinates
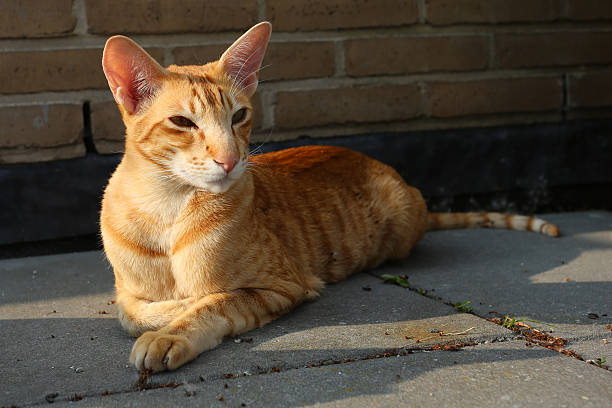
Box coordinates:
[367,272,612,370]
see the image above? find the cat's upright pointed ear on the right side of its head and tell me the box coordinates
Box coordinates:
[219,21,272,98]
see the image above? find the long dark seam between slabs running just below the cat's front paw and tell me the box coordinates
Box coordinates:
[8,337,520,408]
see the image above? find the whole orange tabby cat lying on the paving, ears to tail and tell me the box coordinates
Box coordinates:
[100,23,558,371]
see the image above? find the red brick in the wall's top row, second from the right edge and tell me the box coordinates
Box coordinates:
[426,0,561,25]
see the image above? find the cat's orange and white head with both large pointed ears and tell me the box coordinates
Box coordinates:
[102,22,271,193]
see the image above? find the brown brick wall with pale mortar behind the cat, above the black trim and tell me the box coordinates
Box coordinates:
[0,0,612,163]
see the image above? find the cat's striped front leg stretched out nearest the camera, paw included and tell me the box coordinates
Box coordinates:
[130,284,308,372]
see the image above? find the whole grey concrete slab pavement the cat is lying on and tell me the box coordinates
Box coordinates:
[0,212,612,406]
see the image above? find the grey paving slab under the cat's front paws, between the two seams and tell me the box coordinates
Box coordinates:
[0,252,512,406]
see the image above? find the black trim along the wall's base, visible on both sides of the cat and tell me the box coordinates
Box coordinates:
[0,120,612,249]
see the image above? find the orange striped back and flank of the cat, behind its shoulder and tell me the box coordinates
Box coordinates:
[250,146,427,281]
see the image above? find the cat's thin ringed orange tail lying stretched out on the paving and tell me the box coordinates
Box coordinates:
[428,212,560,237]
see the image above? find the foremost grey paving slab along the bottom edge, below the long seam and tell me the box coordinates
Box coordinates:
[50,341,612,408]
